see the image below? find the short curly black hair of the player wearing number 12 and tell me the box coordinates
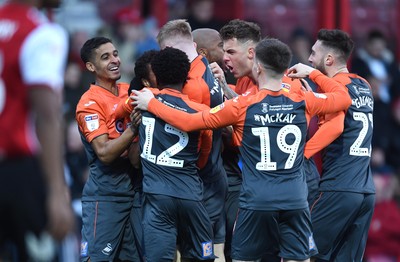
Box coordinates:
[151,47,190,87]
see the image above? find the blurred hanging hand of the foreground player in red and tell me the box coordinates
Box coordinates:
[47,186,75,240]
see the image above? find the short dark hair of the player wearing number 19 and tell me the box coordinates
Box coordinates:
[256,38,292,74]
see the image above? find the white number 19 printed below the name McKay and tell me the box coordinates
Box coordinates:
[251,125,301,171]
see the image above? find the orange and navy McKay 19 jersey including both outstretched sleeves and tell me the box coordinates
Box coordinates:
[148,70,351,210]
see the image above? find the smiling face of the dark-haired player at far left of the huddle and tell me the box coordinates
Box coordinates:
[93,43,121,82]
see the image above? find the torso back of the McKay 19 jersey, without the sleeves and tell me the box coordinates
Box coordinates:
[234,89,307,210]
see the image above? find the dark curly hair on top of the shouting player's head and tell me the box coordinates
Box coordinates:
[219,19,261,43]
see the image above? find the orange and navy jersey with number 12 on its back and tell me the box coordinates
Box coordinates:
[139,89,212,201]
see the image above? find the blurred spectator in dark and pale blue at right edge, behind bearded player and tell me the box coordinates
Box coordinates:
[351,30,400,103]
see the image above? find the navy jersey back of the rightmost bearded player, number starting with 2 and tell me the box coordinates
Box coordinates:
[320,73,375,193]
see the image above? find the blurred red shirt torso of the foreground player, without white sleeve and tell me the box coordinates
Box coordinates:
[0,4,46,157]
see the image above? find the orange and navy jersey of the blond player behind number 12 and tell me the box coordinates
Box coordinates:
[182,55,226,183]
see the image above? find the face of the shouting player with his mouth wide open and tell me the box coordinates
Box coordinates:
[223,38,253,78]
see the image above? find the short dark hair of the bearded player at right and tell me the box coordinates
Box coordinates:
[317,29,354,62]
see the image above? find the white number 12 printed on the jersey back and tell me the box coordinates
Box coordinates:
[140,117,189,167]
